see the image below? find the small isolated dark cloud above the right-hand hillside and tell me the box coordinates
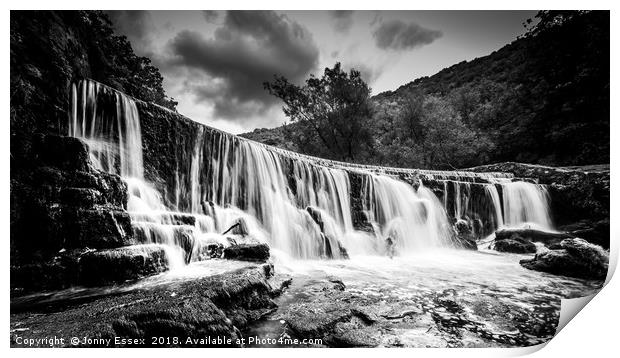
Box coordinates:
[373,20,443,50]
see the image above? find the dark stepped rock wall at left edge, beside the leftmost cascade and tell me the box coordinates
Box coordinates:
[11,135,133,290]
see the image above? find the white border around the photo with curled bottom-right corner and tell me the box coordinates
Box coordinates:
[0,0,620,357]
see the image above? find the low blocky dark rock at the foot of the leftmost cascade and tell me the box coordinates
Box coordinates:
[79,244,168,286]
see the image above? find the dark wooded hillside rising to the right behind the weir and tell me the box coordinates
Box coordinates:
[243,11,609,169]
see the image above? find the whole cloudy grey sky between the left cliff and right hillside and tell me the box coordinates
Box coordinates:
[109,11,536,133]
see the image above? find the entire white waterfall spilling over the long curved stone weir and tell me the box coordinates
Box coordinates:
[69,80,551,265]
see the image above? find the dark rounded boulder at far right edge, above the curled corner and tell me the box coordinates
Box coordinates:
[519,239,609,280]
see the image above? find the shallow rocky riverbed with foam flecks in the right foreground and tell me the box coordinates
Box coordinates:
[245,277,559,348]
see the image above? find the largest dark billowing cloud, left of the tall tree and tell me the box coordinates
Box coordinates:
[167,11,319,119]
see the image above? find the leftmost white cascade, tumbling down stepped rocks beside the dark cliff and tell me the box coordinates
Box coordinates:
[69,80,183,268]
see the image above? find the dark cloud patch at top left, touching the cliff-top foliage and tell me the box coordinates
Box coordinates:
[105,10,155,56]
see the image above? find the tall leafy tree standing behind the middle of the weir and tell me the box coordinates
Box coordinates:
[264,63,372,161]
